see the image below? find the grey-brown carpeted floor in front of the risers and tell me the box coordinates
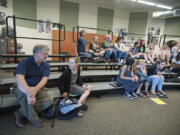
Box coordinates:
[0,90,180,135]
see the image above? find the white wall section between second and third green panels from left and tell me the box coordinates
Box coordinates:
[79,2,98,33]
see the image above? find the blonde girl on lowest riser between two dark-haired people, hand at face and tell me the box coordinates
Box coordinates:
[134,59,150,97]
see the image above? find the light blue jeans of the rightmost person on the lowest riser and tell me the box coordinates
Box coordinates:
[149,75,164,92]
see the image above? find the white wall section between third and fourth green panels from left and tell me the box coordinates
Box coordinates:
[113,9,130,35]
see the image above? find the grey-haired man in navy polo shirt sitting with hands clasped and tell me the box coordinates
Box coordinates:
[13,45,53,128]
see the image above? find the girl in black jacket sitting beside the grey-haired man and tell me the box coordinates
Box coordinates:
[58,57,91,116]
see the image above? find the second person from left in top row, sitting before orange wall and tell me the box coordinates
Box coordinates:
[89,36,105,57]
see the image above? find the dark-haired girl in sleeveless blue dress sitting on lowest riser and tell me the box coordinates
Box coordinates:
[117,57,138,99]
